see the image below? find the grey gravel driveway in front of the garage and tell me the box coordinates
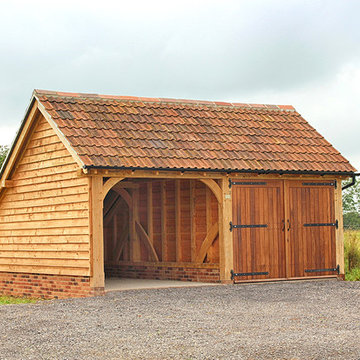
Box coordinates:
[0,280,360,360]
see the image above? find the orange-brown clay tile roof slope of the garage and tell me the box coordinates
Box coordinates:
[34,90,355,173]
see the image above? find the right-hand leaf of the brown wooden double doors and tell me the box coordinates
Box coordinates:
[285,181,337,277]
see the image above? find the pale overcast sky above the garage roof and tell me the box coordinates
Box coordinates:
[0,0,360,170]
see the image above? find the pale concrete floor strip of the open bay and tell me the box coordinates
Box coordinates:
[105,278,221,292]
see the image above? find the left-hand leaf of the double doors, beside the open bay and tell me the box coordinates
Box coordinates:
[232,180,286,281]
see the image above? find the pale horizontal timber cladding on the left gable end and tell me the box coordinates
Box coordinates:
[0,114,90,276]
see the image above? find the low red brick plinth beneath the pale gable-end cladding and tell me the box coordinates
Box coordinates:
[0,272,104,299]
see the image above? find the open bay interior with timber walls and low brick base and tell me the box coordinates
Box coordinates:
[103,178,219,290]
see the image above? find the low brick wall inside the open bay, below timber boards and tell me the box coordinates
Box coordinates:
[105,264,220,283]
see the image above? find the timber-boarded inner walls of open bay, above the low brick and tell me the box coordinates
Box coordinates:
[104,179,219,265]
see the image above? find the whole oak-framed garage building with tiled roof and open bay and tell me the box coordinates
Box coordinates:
[0,91,355,298]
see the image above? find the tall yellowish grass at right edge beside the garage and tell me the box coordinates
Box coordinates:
[344,230,360,281]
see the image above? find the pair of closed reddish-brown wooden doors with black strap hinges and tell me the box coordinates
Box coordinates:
[231,180,338,280]
